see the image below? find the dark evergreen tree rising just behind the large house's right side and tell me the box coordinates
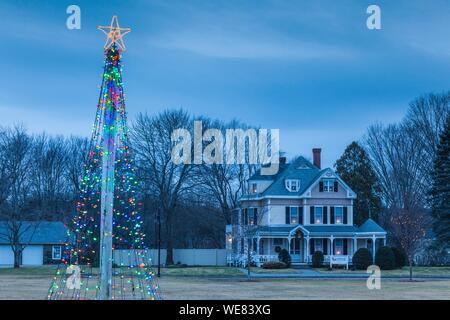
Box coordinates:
[334,141,381,225]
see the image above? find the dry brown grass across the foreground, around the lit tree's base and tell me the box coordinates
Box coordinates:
[0,274,450,299]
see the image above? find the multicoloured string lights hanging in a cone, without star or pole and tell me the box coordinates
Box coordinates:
[48,44,160,299]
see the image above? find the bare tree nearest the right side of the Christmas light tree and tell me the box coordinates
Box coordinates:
[131,110,197,264]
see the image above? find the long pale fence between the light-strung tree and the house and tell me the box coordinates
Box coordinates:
[114,249,227,266]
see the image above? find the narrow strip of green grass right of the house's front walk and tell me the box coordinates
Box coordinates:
[314,267,450,277]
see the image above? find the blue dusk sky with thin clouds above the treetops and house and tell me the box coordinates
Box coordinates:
[0,0,450,166]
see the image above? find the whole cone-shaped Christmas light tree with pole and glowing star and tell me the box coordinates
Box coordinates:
[48,16,160,300]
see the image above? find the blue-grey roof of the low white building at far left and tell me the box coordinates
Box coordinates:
[0,221,68,244]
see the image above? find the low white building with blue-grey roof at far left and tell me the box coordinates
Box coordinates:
[0,221,67,266]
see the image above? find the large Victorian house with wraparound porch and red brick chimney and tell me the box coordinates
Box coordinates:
[226,149,386,266]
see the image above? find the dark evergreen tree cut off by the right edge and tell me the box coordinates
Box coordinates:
[430,113,450,247]
